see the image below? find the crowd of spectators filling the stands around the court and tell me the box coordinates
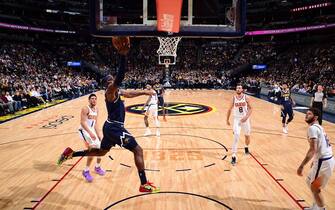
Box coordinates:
[0,38,335,115]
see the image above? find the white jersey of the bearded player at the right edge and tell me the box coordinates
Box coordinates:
[307,124,333,160]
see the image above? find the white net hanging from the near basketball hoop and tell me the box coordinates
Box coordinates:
[157,37,181,56]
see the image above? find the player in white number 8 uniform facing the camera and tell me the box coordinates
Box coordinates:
[227,84,252,165]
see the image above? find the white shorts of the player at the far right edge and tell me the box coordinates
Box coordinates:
[306,157,335,188]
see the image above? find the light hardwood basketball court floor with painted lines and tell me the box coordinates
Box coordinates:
[0,90,335,210]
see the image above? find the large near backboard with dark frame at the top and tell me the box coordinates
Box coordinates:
[89,0,246,37]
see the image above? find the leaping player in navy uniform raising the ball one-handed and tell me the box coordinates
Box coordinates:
[58,37,159,192]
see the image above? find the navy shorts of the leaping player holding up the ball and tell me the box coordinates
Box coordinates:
[101,121,138,151]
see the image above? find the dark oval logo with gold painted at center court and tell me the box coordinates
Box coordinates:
[126,102,213,116]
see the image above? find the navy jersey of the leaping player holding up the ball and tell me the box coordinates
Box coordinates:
[106,92,126,123]
